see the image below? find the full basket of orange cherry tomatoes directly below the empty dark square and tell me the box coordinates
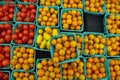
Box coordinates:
[84,33,105,55]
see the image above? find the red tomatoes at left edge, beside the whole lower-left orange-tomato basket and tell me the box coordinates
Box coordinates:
[0,46,10,68]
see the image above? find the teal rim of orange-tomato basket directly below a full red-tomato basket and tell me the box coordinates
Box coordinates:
[10,46,36,71]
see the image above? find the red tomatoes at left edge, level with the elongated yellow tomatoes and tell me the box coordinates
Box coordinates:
[0,23,12,44]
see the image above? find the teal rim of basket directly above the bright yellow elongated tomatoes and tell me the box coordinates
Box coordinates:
[36,6,60,28]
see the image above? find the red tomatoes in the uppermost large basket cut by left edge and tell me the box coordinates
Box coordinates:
[0,3,14,22]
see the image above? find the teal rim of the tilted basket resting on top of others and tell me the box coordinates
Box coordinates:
[50,33,79,64]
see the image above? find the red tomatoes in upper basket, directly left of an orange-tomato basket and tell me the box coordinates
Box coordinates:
[16,4,36,22]
